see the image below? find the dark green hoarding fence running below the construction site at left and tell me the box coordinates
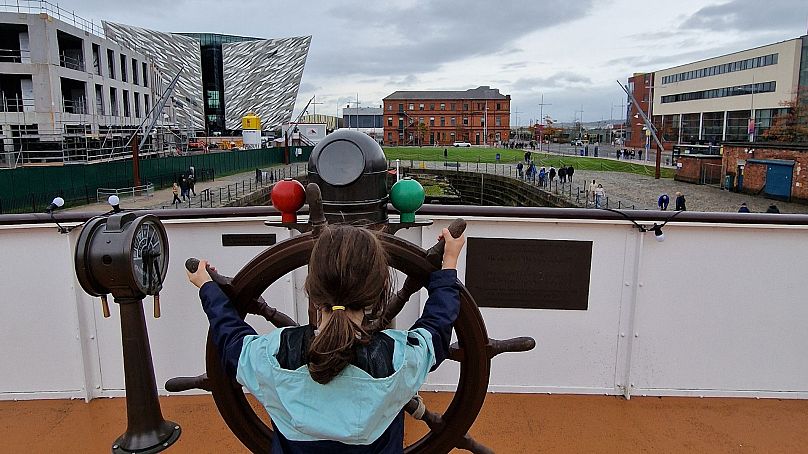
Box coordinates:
[0,147,312,214]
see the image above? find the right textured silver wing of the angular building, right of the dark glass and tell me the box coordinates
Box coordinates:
[222,36,311,130]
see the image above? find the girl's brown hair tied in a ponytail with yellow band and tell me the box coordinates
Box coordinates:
[305,225,391,384]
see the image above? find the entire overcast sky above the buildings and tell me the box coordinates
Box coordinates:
[50,0,808,124]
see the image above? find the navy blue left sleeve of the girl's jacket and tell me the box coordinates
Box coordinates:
[199,282,258,377]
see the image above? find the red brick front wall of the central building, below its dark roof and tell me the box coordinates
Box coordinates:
[382,97,511,146]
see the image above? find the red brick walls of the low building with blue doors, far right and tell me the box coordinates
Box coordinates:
[724,144,808,201]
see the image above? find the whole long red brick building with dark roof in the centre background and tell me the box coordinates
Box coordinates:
[382,86,511,146]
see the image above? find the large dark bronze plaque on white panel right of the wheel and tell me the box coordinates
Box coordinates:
[466,238,592,311]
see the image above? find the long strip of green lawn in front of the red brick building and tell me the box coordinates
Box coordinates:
[384,147,674,178]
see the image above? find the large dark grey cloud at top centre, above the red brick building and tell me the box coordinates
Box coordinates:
[312,0,592,74]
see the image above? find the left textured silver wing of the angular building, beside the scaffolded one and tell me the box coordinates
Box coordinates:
[103,21,205,129]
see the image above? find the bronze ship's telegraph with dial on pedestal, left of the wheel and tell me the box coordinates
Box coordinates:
[75,212,182,454]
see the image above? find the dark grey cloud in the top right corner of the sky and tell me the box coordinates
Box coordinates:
[681,0,808,33]
